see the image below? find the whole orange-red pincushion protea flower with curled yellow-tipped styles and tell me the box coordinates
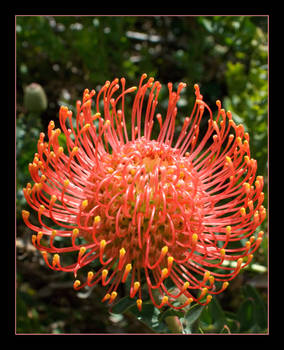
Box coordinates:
[23,74,266,310]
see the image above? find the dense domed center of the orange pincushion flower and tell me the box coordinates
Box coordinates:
[80,138,203,266]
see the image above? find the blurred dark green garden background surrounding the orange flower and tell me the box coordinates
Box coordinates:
[16,16,268,333]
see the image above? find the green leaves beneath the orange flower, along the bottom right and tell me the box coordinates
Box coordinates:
[106,285,267,334]
